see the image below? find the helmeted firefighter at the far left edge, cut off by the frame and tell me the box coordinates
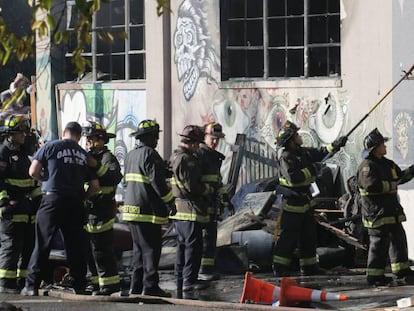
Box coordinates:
[0,115,41,293]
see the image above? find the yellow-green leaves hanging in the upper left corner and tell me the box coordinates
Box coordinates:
[0,0,170,74]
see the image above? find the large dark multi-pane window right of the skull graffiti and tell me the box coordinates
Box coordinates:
[220,0,341,81]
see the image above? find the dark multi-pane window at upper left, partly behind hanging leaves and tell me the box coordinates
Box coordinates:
[65,0,146,81]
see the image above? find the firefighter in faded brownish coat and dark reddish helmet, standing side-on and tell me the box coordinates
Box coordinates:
[170,125,213,292]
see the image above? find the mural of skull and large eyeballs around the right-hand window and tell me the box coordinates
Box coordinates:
[172,0,364,184]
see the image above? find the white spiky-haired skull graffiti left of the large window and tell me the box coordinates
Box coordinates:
[174,0,219,101]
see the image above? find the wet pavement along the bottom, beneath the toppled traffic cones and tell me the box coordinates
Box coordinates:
[0,268,414,311]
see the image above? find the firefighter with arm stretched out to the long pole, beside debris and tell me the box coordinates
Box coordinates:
[273,121,347,277]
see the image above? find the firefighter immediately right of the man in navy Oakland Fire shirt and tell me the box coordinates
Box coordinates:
[82,121,122,296]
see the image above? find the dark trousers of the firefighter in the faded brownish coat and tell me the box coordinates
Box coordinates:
[174,220,203,289]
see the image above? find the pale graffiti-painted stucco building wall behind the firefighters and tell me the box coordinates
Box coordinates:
[34,0,414,253]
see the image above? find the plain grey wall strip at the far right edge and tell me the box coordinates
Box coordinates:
[391,0,414,258]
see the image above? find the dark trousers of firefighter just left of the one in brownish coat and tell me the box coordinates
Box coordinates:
[129,222,162,294]
